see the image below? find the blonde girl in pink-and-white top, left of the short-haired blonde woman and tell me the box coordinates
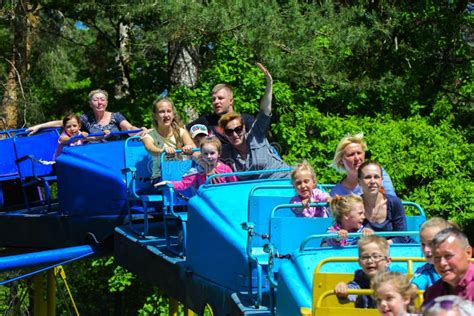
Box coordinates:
[290,161,331,217]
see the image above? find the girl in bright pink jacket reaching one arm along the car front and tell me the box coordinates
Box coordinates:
[155,136,237,191]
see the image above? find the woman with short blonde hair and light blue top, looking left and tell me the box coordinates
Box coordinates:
[330,133,396,196]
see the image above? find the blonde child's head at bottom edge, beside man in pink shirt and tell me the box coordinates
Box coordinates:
[371,271,418,316]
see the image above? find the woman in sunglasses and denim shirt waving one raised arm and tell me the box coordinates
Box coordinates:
[219,64,289,180]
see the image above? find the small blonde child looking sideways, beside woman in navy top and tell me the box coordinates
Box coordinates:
[322,194,374,246]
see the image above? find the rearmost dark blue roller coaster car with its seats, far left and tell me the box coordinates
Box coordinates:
[0,130,146,248]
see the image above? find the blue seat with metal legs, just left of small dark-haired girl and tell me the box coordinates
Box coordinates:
[13,129,59,210]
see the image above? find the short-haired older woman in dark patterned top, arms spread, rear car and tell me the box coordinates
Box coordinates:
[27,89,143,135]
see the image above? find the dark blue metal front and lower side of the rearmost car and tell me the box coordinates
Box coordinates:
[0,130,143,248]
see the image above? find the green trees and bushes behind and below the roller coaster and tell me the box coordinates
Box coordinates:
[0,0,474,315]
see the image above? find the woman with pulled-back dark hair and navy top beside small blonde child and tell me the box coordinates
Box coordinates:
[358,161,412,243]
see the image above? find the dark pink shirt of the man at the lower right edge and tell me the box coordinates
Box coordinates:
[423,262,474,303]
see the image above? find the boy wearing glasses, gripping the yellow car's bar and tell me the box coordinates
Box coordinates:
[334,235,391,308]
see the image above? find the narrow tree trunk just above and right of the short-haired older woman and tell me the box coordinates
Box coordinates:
[115,21,130,99]
